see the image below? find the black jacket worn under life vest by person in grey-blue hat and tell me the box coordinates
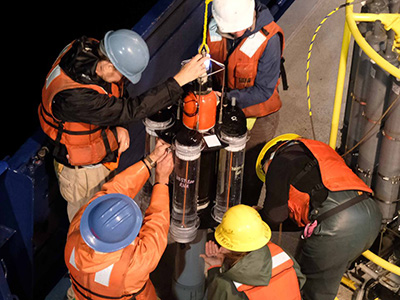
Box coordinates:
[47,36,183,165]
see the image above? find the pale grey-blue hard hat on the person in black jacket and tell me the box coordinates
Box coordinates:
[101,29,150,83]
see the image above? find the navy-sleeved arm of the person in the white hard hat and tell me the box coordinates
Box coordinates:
[227,34,281,108]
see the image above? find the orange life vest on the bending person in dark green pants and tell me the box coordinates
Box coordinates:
[288,139,372,226]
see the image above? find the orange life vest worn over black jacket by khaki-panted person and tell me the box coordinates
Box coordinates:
[38,38,120,169]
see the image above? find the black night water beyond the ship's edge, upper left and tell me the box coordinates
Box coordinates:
[0,0,157,159]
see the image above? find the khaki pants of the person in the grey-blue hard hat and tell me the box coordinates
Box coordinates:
[54,162,112,222]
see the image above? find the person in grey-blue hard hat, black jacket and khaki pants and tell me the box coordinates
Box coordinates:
[38,29,206,221]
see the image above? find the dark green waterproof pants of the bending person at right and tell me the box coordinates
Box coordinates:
[299,191,382,300]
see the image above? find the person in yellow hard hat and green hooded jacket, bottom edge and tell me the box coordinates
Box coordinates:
[201,204,305,300]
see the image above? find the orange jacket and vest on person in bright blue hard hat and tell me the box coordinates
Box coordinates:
[64,161,170,300]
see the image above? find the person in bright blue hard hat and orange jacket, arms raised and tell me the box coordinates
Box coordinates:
[64,140,174,300]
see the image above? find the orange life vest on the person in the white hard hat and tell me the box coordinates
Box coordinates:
[207,19,285,117]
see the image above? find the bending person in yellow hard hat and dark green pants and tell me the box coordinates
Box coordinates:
[256,133,382,300]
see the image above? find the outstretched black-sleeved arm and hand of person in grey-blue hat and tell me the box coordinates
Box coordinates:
[52,54,207,126]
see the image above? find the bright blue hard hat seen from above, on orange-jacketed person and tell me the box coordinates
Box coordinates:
[80,193,143,253]
